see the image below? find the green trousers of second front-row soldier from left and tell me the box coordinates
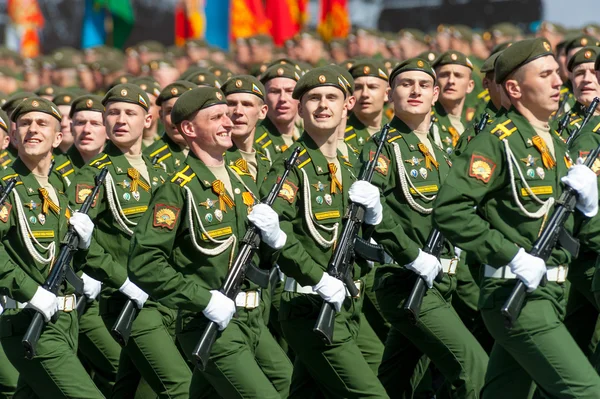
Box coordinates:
[100,296,192,398]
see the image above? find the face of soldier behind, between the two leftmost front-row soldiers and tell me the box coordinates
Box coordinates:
[71,111,106,158]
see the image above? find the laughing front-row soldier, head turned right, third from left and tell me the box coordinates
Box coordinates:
[128,86,292,398]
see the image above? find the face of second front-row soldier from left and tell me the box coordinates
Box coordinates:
[104,102,152,148]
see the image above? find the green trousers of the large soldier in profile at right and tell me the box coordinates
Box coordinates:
[482,290,600,399]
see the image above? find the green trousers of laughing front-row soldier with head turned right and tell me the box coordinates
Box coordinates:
[177,305,292,399]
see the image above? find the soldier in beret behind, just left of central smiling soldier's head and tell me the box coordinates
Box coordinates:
[255,64,300,162]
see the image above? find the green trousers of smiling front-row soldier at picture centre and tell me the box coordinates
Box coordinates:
[279,292,388,398]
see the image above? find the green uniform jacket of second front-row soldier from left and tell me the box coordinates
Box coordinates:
[68,143,166,296]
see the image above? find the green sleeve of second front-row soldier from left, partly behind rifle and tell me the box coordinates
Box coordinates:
[67,167,127,288]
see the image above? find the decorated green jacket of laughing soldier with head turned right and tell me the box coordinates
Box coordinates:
[128,152,272,323]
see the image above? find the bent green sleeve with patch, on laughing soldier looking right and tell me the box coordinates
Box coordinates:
[127,183,211,312]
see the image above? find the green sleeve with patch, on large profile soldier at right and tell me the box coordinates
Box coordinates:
[433,131,519,267]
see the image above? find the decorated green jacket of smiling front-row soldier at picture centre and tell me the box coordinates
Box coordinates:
[261,132,368,286]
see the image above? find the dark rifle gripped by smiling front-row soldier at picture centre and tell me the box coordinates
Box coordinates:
[313,124,390,344]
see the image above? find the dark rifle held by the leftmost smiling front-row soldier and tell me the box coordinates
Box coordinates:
[22,169,108,359]
